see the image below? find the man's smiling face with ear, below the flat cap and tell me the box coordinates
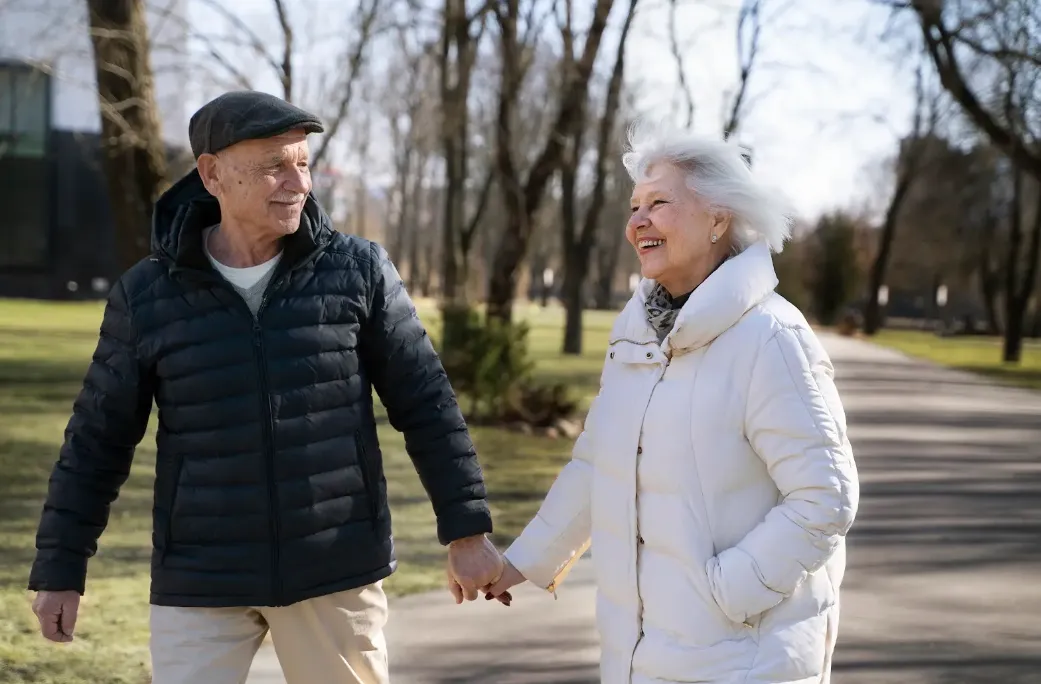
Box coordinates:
[199,130,311,239]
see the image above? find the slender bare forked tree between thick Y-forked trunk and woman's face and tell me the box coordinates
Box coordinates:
[560,0,639,354]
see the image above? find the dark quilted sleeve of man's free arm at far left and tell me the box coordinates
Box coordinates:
[29,282,154,593]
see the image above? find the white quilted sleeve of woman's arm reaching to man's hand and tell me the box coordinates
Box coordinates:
[505,387,596,591]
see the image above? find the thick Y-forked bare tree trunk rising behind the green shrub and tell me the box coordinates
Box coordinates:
[488,0,613,321]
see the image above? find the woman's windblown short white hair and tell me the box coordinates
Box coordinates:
[621,124,792,252]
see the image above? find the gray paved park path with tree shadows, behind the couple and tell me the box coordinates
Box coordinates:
[249,335,1041,684]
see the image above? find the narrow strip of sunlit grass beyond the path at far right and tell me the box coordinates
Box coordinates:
[870,330,1041,389]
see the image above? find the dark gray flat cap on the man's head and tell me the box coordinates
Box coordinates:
[188,91,325,159]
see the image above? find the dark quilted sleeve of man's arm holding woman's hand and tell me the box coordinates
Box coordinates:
[361,244,491,544]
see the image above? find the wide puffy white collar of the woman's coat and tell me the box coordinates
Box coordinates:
[610,242,778,354]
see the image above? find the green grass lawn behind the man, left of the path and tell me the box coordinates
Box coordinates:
[0,300,613,684]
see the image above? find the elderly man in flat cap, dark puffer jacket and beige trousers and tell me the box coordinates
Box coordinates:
[29,92,503,684]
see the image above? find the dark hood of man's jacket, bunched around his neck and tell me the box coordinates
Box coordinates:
[152,169,333,269]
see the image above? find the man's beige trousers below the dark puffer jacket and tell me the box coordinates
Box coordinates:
[150,582,390,684]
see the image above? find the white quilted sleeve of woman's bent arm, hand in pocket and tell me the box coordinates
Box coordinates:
[706,328,860,623]
